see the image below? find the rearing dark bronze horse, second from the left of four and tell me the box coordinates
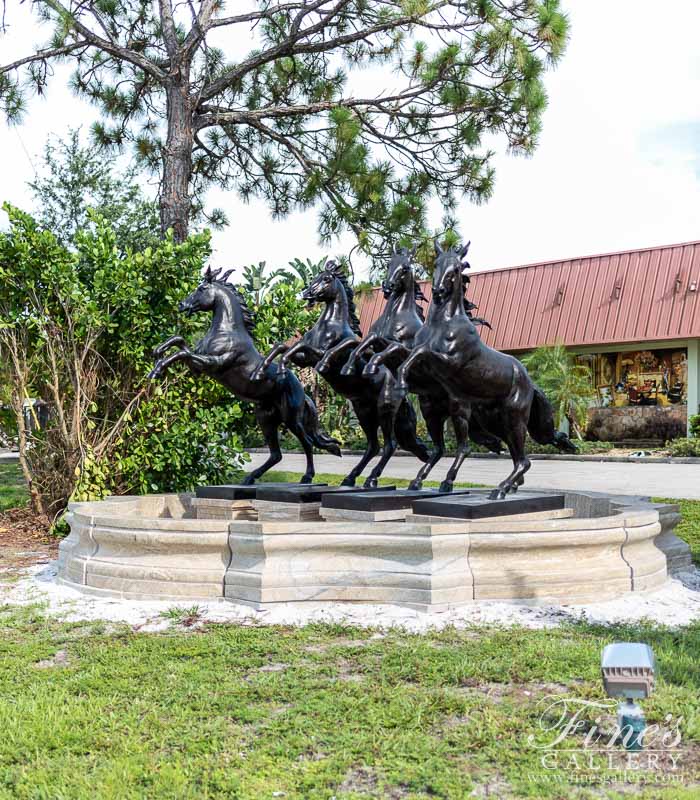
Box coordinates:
[254,261,429,488]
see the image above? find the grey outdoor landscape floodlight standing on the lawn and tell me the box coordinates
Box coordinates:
[600,642,656,750]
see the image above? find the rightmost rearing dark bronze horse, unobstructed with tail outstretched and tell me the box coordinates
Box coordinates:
[395,242,576,499]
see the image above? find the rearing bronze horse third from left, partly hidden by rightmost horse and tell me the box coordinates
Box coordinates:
[340,247,501,491]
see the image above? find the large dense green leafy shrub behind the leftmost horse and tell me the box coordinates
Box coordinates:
[0,205,246,518]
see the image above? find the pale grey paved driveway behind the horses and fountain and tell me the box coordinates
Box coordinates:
[248,453,700,499]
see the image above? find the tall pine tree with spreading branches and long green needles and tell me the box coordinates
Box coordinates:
[0,0,567,254]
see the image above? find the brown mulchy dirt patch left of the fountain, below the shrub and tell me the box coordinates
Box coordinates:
[0,508,59,583]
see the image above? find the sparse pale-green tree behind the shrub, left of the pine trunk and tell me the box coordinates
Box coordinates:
[29,130,160,251]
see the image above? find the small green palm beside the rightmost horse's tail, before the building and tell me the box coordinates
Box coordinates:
[522,343,594,439]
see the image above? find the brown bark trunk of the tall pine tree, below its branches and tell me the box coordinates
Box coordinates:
[160,82,194,242]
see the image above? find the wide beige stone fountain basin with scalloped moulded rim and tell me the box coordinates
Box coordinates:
[58,492,690,609]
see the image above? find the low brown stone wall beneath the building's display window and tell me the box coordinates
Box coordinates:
[586,404,688,442]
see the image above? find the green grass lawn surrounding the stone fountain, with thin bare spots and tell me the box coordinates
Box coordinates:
[0,465,700,800]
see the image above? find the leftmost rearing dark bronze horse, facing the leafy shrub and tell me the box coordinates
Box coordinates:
[149,268,340,484]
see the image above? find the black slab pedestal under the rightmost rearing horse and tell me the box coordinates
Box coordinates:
[412,489,564,520]
